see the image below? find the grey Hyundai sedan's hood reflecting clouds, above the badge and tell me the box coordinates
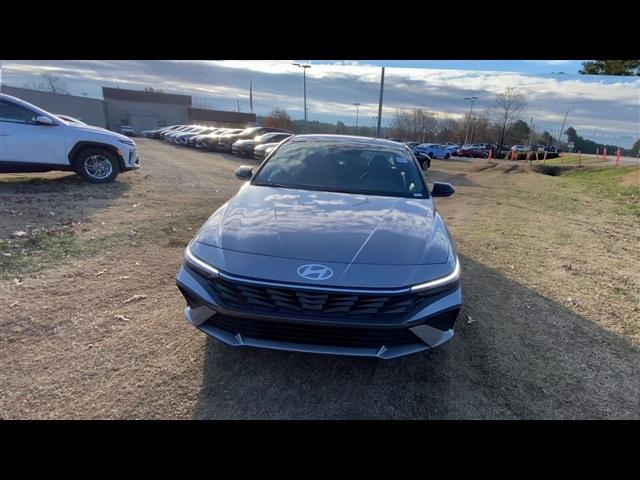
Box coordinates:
[196,183,451,265]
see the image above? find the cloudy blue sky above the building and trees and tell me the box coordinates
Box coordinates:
[0,60,640,148]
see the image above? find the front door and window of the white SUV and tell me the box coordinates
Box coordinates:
[0,99,69,165]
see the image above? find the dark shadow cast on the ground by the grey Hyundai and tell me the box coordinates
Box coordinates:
[194,257,640,419]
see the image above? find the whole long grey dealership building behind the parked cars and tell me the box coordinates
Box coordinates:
[1,85,256,132]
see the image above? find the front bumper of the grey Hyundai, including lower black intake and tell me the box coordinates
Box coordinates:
[176,265,462,359]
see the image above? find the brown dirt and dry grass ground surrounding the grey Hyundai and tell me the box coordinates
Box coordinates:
[0,140,640,419]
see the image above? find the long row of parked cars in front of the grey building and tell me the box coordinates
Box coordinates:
[142,125,293,160]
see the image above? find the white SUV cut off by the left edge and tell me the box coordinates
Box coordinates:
[0,93,140,183]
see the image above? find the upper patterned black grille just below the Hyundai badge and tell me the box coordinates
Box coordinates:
[211,278,424,319]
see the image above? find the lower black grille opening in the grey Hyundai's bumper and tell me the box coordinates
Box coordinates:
[207,314,420,348]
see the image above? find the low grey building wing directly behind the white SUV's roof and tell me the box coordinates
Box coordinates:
[0,85,107,128]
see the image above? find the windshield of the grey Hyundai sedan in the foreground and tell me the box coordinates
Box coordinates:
[252,141,429,198]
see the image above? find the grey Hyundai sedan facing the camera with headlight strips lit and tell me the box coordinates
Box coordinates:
[176,135,462,359]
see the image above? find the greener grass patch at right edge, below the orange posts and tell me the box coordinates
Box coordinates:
[560,166,640,217]
